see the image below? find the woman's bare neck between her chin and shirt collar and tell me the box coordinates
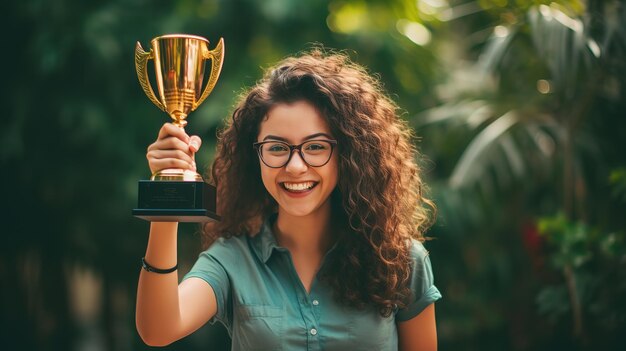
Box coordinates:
[275,203,331,255]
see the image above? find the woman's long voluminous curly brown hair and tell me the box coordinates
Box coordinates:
[203,49,435,316]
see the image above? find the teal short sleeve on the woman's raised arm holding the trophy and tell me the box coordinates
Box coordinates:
[183,243,232,331]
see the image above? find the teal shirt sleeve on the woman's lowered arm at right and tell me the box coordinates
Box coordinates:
[396,240,441,322]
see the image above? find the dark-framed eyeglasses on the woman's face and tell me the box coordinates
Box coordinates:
[252,140,337,168]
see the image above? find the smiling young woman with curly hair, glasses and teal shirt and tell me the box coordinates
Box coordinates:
[137,50,441,350]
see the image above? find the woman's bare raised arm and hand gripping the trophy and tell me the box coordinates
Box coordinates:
[136,123,217,346]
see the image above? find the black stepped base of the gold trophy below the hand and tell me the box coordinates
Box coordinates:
[133,180,220,222]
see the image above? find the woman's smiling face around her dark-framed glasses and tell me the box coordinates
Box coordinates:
[257,101,339,217]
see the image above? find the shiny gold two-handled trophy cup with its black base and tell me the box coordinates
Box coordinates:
[133,34,224,222]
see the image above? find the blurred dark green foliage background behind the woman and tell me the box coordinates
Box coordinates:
[0,0,626,350]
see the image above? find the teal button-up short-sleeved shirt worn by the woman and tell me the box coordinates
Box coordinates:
[184,220,441,351]
